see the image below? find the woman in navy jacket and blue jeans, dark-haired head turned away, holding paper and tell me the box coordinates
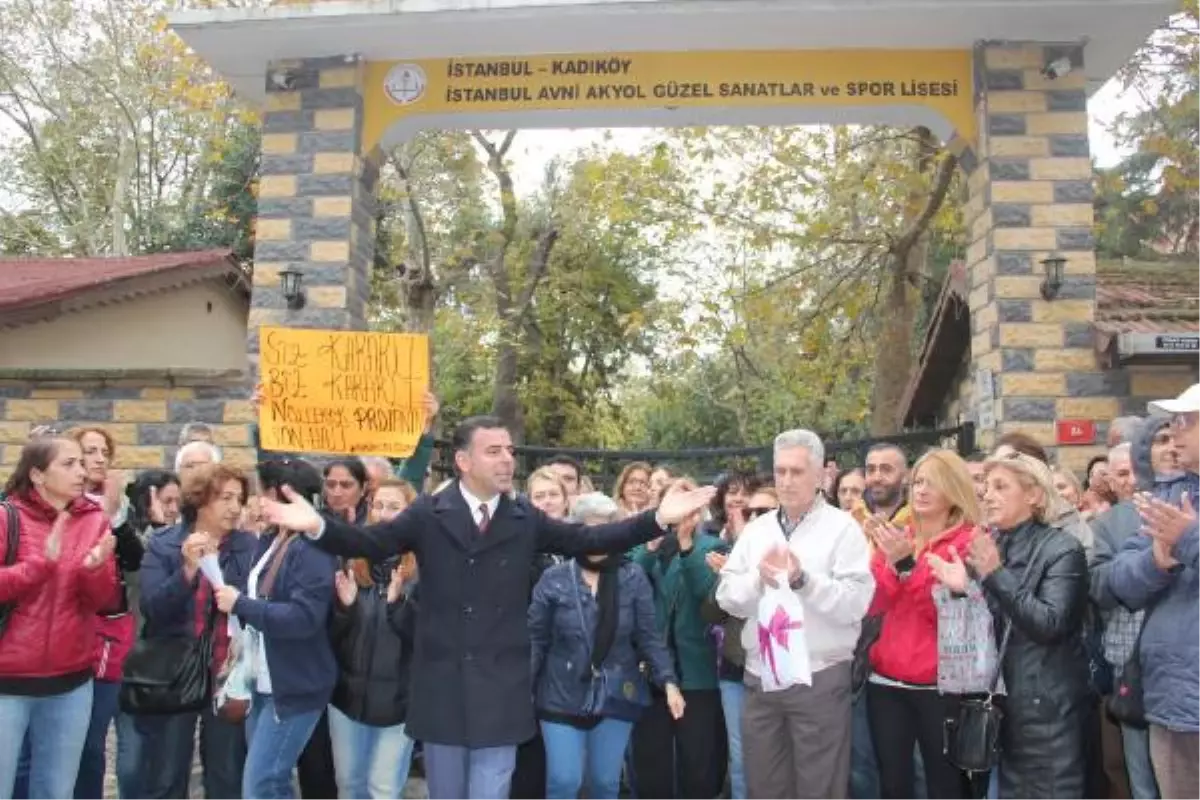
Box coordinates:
[216,458,337,800]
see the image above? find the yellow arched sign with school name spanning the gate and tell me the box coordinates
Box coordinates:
[362,49,976,151]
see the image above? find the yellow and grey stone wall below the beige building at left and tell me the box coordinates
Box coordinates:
[0,375,256,480]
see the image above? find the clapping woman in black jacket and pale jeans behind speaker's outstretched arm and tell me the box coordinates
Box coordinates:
[329,480,416,800]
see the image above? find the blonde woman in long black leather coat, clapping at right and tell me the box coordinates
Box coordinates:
[935,453,1088,800]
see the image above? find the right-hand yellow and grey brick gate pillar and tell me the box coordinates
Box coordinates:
[966,43,1104,467]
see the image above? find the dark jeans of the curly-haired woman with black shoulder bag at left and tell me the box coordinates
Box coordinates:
[138,708,246,800]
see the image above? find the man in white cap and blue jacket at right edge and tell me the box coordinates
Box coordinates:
[1109,384,1200,800]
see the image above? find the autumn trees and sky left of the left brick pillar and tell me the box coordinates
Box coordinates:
[0,0,257,258]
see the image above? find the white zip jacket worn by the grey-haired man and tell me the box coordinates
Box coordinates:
[716,497,875,675]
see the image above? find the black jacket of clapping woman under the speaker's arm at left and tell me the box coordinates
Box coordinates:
[330,559,418,727]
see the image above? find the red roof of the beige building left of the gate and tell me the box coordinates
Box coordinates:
[0,249,236,313]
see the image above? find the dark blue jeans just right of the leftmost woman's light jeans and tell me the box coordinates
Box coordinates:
[74,680,140,800]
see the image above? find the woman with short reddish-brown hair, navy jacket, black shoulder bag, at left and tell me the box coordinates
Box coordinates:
[138,464,258,800]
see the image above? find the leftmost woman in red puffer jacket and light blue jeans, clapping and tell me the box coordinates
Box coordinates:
[0,438,120,800]
